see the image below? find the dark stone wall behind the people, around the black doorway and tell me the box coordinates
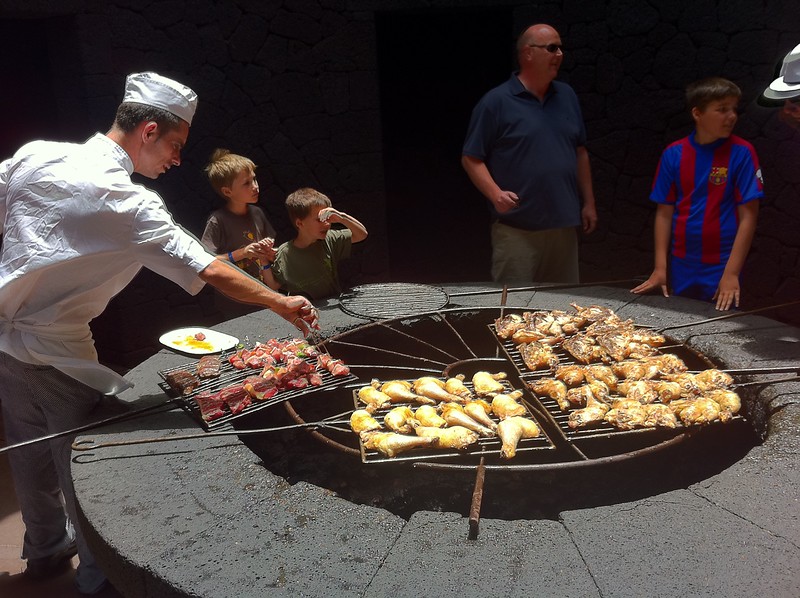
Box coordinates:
[0,0,800,367]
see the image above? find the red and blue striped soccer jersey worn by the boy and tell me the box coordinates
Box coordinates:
[650,134,764,264]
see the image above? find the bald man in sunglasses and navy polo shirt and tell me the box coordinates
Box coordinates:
[461,25,597,282]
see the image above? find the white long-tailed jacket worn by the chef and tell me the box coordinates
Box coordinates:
[0,133,214,394]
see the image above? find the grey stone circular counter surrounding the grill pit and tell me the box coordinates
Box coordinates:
[73,284,800,598]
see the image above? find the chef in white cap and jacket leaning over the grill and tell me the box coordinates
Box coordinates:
[0,73,317,594]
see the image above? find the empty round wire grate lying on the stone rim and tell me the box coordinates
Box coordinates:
[339,282,450,320]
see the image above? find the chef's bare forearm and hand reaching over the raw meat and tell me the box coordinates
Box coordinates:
[199,260,318,332]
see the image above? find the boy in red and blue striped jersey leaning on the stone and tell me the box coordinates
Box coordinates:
[632,77,764,310]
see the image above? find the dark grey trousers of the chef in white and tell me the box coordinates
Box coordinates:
[0,352,105,593]
